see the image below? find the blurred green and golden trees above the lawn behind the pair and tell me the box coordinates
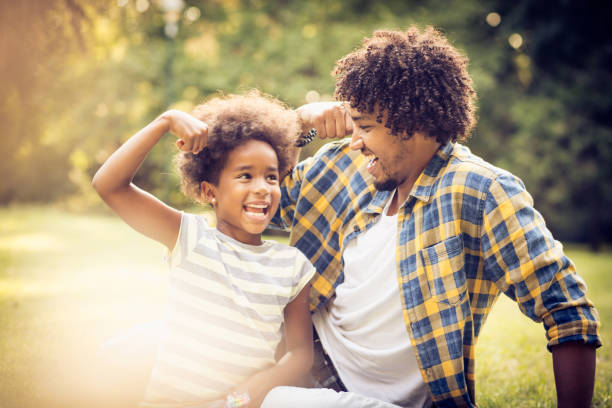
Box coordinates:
[0,0,612,246]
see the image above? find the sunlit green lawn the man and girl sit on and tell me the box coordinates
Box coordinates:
[0,207,612,408]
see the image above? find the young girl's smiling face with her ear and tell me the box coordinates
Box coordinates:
[203,140,280,245]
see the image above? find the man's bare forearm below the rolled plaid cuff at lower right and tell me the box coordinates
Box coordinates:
[552,342,595,408]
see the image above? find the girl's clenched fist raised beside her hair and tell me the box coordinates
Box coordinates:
[160,109,208,154]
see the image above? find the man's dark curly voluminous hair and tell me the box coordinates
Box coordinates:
[332,26,476,144]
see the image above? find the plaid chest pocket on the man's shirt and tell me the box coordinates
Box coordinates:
[419,235,467,305]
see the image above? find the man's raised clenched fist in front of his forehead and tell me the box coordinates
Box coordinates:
[297,102,353,139]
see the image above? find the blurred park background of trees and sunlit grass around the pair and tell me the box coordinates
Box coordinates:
[0,0,612,408]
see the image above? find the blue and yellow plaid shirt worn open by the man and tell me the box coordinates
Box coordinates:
[274,140,601,406]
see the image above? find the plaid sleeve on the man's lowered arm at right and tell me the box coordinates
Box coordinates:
[480,173,601,350]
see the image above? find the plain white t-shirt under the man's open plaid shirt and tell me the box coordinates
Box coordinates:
[313,195,431,407]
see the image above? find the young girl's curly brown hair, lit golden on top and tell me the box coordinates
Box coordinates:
[174,91,299,201]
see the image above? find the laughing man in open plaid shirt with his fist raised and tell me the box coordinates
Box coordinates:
[262,27,601,408]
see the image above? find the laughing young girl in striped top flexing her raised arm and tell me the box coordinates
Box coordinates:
[93,93,314,407]
